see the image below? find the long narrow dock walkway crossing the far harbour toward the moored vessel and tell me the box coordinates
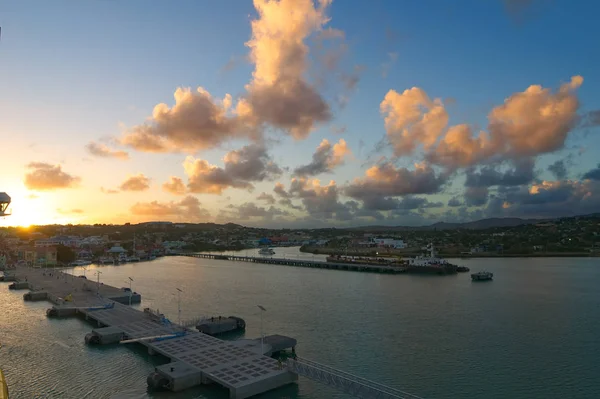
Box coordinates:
[174,252,406,274]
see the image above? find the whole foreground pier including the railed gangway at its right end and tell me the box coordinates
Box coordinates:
[1,267,417,399]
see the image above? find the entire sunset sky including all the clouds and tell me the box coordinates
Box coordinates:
[0,0,600,228]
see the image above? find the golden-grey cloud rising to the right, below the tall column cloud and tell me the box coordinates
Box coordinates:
[184,144,283,194]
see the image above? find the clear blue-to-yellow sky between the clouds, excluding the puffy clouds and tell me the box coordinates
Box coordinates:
[0,0,600,226]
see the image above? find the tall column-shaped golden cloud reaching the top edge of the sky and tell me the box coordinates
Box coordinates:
[237,0,339,139]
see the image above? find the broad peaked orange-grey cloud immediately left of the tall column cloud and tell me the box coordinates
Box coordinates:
[121,87,251,152]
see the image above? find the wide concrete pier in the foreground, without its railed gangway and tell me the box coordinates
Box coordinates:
[2,268,297,399]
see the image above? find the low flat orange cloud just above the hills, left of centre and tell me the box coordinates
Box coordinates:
[130,195,210,222]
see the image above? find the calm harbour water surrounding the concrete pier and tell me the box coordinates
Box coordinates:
[0,248,600,399]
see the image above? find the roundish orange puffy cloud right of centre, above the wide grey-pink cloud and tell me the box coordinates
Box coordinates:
[380,87,448,156]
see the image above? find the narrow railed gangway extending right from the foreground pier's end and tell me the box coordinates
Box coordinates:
[285,357,423,399]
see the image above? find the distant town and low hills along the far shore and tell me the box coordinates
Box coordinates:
[0,214,600,267]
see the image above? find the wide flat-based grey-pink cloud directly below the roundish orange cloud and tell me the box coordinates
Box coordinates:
[345,162,447,199]
